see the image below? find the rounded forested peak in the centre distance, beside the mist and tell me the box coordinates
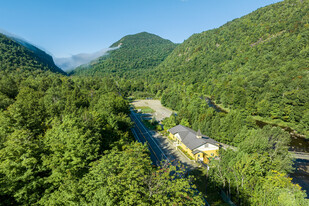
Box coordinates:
[73,32,176,76]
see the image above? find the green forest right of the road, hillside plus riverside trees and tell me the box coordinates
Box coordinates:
[68,0,309,205]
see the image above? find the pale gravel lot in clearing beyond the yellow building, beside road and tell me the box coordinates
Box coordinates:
[132,99,172,121]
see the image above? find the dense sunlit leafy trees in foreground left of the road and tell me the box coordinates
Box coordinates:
[0,72,203,205]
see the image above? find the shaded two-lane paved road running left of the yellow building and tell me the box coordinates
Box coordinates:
[130,110,171,165]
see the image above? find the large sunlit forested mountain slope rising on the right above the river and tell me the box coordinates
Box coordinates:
[147,0,309,134]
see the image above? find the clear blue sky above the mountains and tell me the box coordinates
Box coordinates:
[0,0,279,57]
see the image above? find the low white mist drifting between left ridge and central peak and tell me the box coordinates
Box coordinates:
[54,47,118,72]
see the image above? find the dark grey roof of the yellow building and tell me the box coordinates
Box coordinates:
[168,125,218,150]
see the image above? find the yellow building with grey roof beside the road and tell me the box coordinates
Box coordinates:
[168,125,219,164]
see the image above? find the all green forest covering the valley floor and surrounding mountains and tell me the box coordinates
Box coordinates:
[0,0,309,206]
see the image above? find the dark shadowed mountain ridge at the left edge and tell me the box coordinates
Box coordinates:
[0,33,66,74]
